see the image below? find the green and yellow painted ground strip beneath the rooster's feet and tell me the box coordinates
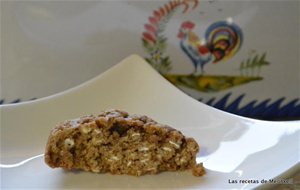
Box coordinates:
[164,74,263,92]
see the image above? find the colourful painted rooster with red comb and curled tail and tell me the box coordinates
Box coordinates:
[178,18,243,74]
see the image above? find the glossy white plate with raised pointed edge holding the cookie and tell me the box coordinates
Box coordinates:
[0,55,300,189]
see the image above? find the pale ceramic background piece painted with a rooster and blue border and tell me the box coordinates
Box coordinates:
[0,0,300,119]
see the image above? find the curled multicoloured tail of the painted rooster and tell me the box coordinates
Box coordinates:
[205,21,243,63]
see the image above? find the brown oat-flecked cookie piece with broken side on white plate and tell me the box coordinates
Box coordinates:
[45,110,204,176]
